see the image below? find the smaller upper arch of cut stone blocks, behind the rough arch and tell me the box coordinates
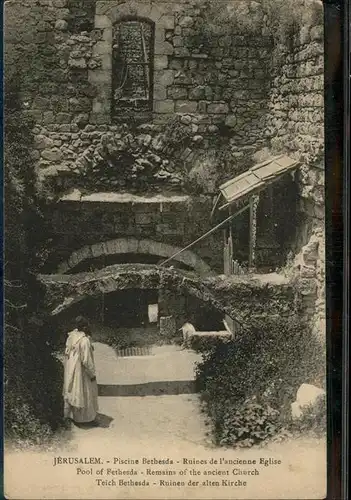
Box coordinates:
[57,238,213,276]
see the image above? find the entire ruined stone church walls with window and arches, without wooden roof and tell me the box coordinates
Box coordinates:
[5,0,325,338]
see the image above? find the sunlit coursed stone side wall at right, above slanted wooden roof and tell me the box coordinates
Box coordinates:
[266,1,324,233]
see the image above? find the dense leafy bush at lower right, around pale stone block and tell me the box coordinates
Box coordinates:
[197,318,325,447]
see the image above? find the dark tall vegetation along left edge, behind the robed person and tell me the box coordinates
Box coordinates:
[4,79,62,450]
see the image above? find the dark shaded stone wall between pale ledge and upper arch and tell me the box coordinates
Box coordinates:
[45,197,223,273]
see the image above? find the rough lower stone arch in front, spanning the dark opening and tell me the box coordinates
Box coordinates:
[37,264,301,326]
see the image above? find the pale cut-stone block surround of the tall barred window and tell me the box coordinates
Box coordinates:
[89,1,174,123]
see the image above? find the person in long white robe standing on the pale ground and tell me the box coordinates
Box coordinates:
[63,318,98,423]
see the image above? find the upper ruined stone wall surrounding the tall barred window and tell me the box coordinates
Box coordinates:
[5,0,323,197]
